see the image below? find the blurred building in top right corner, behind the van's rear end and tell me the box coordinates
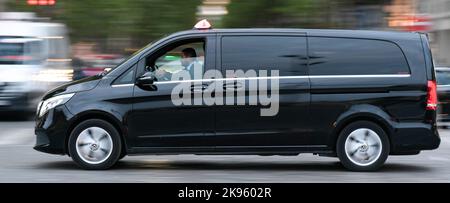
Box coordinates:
[416,0,450,66]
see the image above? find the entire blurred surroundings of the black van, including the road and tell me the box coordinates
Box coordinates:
[0,0,450,182]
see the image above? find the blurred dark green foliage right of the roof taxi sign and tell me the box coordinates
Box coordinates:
[223,0,380,28]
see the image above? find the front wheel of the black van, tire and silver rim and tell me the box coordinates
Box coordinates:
[68,119,122,170]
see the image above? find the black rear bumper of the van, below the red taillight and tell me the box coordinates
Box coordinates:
[391,123,441,154]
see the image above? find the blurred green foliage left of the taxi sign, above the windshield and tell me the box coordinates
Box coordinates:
[8,0,201,44]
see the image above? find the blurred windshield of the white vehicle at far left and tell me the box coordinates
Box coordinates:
[0,41,42,65]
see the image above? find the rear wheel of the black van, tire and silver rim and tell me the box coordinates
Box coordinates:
[336,121,390,171]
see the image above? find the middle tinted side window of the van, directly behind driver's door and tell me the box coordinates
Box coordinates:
[222,36,307,76]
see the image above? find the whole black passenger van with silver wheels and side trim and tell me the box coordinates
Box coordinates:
[34,22,440,171]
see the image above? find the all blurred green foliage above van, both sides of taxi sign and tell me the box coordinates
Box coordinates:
[8,0,387,47]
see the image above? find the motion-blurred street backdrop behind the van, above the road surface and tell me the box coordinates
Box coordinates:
[0,0,450,116]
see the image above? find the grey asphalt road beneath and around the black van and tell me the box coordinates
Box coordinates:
[0,120,450,182]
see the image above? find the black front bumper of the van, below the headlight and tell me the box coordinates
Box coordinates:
[34,105,73,154]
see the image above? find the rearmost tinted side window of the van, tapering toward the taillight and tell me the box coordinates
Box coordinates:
[308,37,410,75]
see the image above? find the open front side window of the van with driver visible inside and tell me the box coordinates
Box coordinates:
[145,41,205,81]
